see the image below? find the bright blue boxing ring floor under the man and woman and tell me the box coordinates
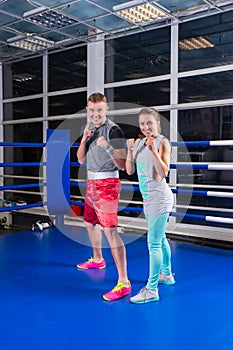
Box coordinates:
[0,227,233,350]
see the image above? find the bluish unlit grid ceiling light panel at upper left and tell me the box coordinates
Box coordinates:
[24,10,78,30]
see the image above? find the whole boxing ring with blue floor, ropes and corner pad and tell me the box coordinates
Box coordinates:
[0,133,233,350]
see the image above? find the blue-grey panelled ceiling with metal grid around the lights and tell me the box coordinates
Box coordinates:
[0,0,233,62]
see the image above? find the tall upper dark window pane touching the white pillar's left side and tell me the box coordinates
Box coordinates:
[48,46,87,91]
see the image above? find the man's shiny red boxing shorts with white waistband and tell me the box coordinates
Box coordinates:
[84,178,121,227]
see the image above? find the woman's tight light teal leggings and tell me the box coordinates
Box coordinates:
[146,213,171,289]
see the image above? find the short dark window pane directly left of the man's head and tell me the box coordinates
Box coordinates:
[49,92,87,116]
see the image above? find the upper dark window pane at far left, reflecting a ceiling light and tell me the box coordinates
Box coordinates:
[3,57,43,98]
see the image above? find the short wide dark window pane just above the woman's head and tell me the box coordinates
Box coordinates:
[106,80,170,109]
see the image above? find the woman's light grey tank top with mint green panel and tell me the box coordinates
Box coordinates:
[136,135,174,214]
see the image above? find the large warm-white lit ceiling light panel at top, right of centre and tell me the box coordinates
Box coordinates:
[116,3,168,24]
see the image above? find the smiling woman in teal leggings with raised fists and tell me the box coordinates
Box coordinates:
[126,108,175,304]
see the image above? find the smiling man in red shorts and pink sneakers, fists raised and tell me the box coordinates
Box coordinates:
[77,93,131,301]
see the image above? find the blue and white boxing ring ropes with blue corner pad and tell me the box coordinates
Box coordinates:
[0,133,233,240]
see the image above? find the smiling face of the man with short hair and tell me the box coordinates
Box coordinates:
[87,101,108,128]
